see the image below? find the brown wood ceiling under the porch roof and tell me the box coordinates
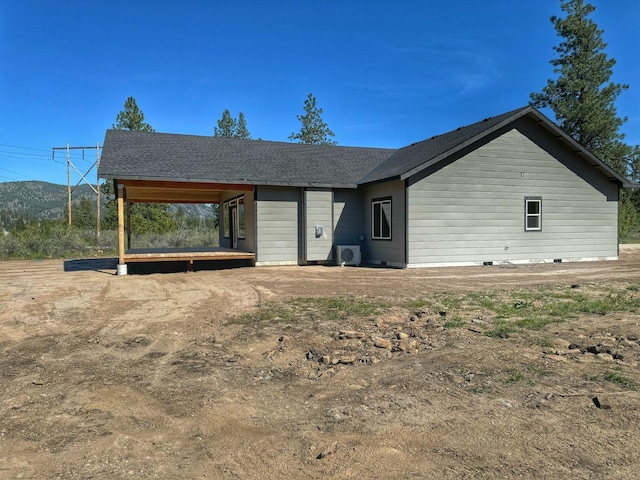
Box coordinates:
[117,180,253,203]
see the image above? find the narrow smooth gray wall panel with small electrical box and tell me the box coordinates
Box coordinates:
[304,190,333,261]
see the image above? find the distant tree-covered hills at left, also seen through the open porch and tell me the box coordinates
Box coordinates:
[0,180,215,227]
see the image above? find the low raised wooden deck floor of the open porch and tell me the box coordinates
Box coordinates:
[124,247,256,265]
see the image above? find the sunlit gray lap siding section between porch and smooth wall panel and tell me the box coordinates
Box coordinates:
[255,187,301,265]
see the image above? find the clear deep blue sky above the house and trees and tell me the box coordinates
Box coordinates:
[0,0,640,184]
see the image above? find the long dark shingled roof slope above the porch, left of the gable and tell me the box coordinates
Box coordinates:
[98,130,394,188]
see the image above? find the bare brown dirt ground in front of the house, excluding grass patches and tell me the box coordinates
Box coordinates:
[0,251,640,479]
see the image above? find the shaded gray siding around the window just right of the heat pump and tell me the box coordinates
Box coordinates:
[363,180,406,267]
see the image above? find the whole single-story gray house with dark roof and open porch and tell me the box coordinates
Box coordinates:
[99,106,631,276]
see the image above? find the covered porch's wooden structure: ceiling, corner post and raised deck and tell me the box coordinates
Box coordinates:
[114,179,255,275]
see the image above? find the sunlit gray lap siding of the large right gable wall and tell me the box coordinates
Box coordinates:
[407,117,618,266]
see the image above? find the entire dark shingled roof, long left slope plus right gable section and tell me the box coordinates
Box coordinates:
[98,106,631,188]
